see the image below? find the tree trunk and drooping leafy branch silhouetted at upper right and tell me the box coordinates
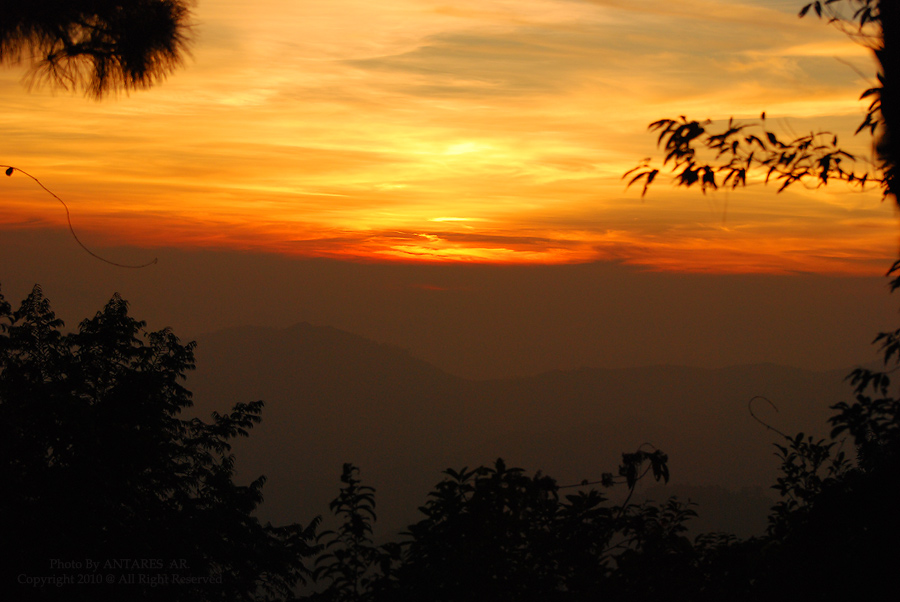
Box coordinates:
[624,0,900,202]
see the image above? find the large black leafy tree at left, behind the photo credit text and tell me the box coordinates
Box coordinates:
[0,286,317,601]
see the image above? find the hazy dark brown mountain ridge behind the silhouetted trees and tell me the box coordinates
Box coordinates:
[188,323,850,532]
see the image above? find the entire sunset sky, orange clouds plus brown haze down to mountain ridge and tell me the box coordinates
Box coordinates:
[0,0,898,380]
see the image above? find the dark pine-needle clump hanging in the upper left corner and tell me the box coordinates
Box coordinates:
[0,0,192,98]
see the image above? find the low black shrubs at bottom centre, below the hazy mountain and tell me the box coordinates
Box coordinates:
[308,450,693,602]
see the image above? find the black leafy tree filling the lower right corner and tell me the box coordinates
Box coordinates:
[732,366,900,601]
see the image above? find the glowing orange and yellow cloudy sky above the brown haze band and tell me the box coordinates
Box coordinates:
[0,0,897,274]
